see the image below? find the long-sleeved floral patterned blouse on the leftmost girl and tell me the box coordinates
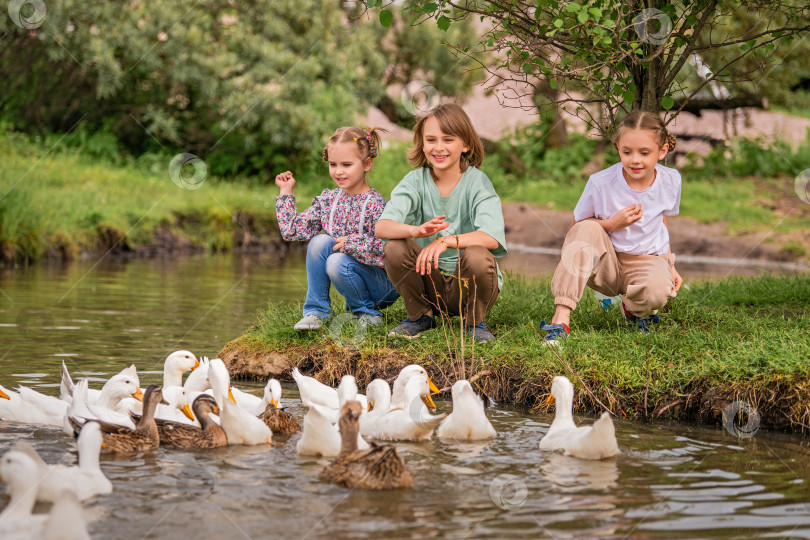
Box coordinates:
[276,188,385,268]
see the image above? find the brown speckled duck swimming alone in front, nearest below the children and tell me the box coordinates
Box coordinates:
[318,401,413,489]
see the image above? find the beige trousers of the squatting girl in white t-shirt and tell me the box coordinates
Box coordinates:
[551,220,675,317]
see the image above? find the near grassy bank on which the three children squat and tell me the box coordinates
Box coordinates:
[220,276,810,430]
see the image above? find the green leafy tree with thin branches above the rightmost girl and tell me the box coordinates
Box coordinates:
[366,0,810,134]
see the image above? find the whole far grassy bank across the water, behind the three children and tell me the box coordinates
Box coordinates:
[0,127,810,260]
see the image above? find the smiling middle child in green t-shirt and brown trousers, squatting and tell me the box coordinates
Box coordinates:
[375,103,506,343]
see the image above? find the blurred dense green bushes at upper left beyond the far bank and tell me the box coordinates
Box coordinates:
[0,0,475,179]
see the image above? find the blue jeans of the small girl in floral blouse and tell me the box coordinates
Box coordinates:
[304,234,399,318]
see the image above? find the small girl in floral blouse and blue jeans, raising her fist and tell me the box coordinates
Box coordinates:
[276,127,399,330]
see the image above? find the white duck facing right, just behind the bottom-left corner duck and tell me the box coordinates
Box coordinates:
[14,422,112,502]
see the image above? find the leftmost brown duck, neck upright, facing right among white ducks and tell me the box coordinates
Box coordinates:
[70,385,168,454]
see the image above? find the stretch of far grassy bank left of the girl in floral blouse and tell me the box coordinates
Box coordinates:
[0,136,278,260]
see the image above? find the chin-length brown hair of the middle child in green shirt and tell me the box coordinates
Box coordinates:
[408,103,484,172]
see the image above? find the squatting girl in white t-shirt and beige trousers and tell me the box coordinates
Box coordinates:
[540,111,683,345]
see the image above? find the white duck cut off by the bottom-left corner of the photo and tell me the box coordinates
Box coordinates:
[0,450,90,540]
